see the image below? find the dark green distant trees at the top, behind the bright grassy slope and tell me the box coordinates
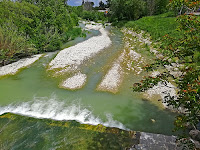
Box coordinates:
[107,0,169,21]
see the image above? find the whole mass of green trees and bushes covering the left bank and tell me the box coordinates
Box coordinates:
[0,0,82,65]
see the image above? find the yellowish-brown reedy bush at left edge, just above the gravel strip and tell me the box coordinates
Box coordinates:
[0,24,36,65]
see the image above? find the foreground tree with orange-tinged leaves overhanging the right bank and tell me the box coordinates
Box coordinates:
[133,0,200,148]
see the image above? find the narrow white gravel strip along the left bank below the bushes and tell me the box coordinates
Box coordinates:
[0,54,42,76]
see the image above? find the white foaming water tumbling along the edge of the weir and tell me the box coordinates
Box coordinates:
[0,97,126,129]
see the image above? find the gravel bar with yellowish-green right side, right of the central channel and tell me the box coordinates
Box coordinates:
[97,27,146,94]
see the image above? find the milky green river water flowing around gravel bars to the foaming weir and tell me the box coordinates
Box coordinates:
[0,26,175,149]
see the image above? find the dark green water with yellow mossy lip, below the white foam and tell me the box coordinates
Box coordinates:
[0,113,139,150]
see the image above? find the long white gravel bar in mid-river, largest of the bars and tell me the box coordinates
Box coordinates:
[49,24,111,71]
